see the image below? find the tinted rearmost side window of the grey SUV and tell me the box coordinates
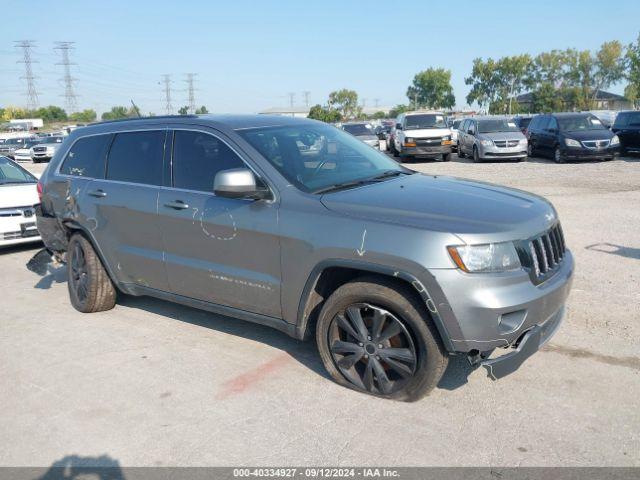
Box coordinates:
[60,135,111,178]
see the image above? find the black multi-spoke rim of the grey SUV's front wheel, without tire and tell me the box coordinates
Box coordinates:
[328,303,417,395]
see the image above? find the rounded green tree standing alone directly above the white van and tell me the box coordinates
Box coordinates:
[407,68,456,108]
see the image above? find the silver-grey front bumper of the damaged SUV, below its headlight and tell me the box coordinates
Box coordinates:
[431,250,574,353]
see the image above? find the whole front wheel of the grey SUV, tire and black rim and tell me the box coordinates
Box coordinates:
[316,277,448,401]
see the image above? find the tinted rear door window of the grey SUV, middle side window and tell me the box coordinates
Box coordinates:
[107,131,165,185]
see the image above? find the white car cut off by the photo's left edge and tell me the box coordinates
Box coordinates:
[0,157,40,247]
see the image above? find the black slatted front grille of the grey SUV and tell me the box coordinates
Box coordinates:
[527,223,567,283]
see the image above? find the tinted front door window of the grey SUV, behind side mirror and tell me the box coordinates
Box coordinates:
[173,130,246,192]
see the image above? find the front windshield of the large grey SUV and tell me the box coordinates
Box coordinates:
[238,124,408,192]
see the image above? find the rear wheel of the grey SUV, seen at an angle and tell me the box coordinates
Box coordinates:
[67,233,116,313]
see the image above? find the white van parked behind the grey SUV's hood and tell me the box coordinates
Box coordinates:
[392,111,452,162]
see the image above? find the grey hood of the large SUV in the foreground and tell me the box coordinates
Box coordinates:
[322,174,556,243]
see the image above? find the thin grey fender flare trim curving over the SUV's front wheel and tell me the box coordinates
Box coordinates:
[296,259,455,352]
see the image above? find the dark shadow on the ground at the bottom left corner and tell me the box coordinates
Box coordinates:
[36,455,126,480]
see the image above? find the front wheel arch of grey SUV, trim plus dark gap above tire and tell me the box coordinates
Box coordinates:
[296,259,454,351]
